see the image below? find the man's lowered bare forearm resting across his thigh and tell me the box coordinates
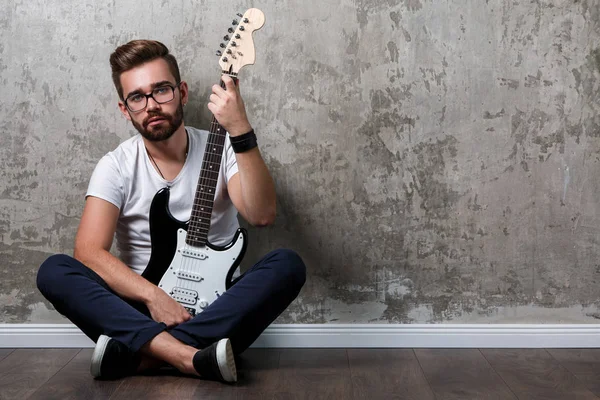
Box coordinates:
[74,249,160,303]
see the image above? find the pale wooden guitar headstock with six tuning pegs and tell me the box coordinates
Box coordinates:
[217,8,265,74]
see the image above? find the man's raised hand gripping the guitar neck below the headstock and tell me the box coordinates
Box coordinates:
[208,75,252,136]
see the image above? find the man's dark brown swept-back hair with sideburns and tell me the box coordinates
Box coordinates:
[110,40,181,100]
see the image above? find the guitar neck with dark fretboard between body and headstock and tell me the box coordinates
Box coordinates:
[185,72,235,247]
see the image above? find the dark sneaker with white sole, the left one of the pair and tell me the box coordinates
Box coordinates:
[90,335,140,379]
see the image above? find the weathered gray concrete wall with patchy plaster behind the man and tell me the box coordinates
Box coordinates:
[0,0,600,323]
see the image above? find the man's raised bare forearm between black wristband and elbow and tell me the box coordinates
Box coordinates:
[236,148,277,226]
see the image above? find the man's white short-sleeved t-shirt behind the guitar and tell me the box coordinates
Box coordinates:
[86,127,239,274]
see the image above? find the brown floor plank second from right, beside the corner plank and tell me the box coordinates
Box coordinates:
[482,349,598,400]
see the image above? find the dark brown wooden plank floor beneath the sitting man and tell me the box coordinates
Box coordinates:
[0,349,600,400]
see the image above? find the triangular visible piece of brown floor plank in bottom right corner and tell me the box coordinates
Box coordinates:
[548,349,600,397]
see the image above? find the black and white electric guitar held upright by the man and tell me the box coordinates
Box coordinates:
[142,8,265,316]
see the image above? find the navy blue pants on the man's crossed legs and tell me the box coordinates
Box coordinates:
[37,250,306,354]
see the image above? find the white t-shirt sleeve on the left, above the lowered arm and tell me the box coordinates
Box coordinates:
[85,154,125,209]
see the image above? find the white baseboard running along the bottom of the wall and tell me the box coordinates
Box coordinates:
[0,324,600,348]
